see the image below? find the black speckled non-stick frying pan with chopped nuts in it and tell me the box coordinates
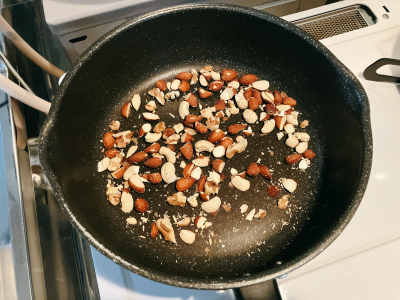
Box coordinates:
[40,4,372,289]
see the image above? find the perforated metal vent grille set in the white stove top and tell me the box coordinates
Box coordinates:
[293,5,376,40]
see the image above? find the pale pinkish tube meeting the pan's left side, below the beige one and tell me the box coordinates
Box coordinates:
[0,74,51,114]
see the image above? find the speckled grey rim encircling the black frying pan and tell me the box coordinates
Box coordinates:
[39,3,372,289]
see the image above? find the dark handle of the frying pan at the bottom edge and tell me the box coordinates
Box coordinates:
[233,279,282,300]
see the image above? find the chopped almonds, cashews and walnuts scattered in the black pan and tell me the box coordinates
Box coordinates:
[98,66,315,244]
